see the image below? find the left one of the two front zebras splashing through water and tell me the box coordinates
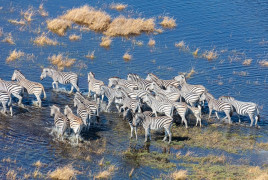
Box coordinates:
[50,105,70,140]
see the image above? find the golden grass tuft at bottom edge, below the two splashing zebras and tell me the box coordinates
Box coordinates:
[48,165,77,180]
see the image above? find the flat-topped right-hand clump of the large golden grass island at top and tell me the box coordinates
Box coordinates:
[104,16,155,36]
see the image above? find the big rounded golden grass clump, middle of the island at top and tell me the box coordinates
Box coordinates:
[61,5,111,31]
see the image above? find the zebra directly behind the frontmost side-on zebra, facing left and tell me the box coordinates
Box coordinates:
[142,95,175,118]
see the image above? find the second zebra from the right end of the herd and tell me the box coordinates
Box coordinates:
[202,91,233,124]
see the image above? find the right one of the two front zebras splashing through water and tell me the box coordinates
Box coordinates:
[64,105,84,144]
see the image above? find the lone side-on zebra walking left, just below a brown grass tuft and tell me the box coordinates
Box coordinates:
[40,68,80,94]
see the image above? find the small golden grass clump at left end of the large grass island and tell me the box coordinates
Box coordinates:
[47,18,72,36]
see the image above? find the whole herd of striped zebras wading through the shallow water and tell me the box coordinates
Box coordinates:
[0,68,259,143]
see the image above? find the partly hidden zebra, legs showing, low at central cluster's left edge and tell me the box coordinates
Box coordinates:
[100,86,123,111]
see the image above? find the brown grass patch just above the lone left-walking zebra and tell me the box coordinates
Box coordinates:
[48,54,76,70]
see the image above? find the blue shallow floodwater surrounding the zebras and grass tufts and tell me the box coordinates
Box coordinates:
[0,0,268,179]
